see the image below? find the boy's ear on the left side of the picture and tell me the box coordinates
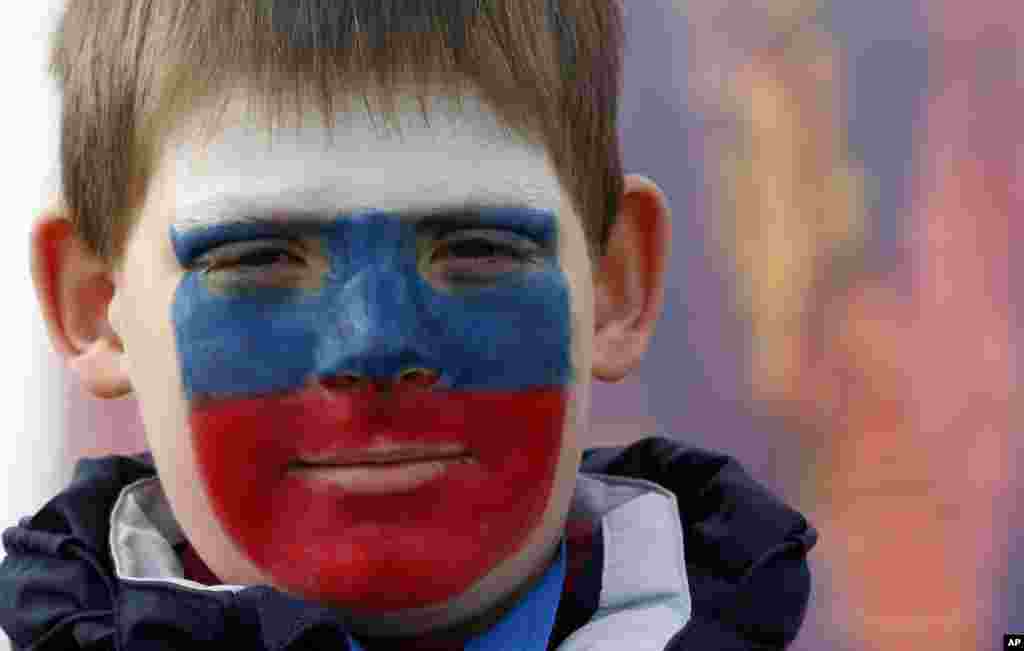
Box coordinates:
[30,203,131,398]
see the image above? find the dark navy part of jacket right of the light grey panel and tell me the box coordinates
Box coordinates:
[581,436,818,650]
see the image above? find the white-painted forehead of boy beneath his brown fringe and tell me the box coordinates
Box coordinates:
[174,92,561,232]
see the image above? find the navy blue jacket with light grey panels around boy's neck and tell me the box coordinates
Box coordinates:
[0,437,818,651]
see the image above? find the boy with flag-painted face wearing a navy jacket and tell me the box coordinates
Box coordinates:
[0,0,817,651]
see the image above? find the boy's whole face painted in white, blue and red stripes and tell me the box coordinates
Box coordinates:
[110,90,594,628]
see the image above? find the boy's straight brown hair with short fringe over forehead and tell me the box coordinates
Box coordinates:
[50,0,624,266]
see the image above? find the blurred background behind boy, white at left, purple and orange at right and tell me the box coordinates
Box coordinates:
[0,0,1024,651]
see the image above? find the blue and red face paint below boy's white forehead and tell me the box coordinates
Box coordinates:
[171,208,572,612]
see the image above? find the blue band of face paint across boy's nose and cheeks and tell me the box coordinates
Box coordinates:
[165,209,571,400]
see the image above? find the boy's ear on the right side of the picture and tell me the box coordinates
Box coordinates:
[593,174,672,382]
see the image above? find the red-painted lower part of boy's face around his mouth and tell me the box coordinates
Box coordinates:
[190,387,566,613]
